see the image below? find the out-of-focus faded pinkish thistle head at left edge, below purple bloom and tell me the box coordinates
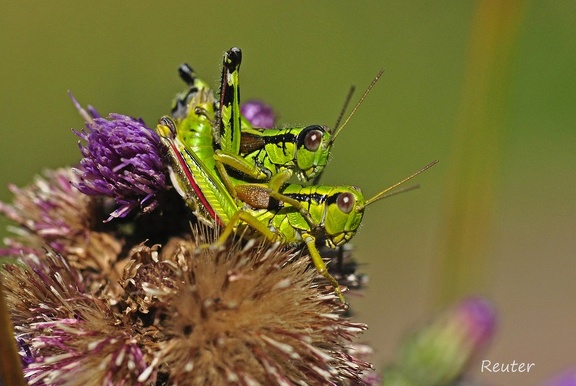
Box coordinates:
[0,169,122,275]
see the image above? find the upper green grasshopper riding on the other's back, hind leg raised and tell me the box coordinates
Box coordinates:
[172,48,383,191]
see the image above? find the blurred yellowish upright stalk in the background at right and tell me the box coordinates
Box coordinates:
[436,0,525,305]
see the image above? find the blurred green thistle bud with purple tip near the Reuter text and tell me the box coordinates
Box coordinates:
[384,298,496,386]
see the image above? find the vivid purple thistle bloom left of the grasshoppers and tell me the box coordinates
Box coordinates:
[74,114,166,221]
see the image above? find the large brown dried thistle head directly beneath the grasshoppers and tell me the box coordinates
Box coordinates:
[125,240,369,385]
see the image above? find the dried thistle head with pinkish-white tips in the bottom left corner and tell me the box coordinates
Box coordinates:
[1,252,151,385]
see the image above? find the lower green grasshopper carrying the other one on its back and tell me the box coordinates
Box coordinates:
[157,113,435,302]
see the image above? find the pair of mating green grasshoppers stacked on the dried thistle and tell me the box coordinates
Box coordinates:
[157,48,432,301]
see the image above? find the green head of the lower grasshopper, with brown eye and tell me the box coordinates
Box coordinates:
[324,186,365,248]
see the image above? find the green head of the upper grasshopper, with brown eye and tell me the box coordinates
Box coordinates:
[295,125,333,181]
